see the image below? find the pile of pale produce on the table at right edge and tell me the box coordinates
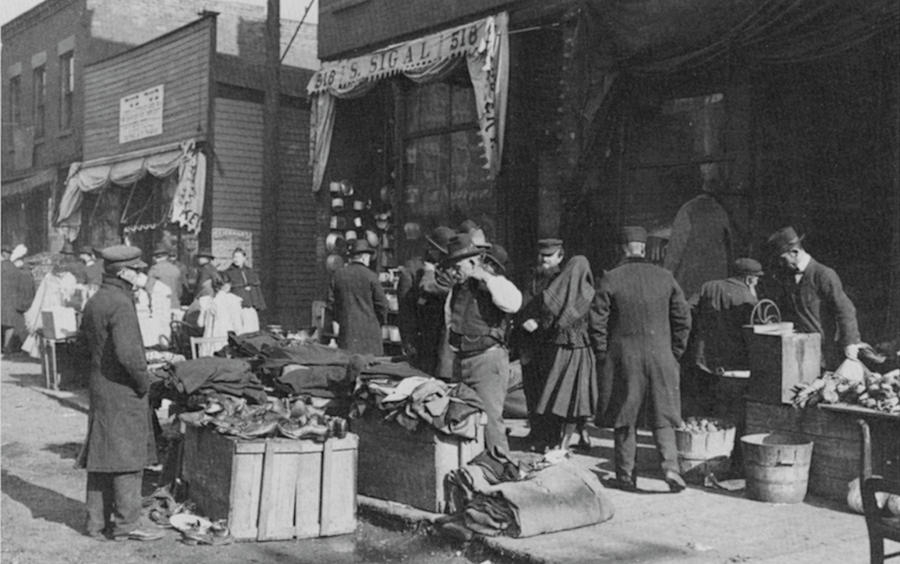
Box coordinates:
[792,363,900,415]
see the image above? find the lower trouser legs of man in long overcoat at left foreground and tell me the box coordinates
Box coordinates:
[86,471,143,536]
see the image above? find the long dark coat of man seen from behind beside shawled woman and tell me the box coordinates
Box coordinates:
[597,260,691,428]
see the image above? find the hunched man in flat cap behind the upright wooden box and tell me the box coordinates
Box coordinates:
[682,258,763,416]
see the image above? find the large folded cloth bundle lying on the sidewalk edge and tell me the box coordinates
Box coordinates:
[445,450,615,538]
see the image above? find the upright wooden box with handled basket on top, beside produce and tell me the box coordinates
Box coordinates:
[748,331,822,403]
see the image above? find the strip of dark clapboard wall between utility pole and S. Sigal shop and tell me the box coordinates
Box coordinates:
[273,106,325,327]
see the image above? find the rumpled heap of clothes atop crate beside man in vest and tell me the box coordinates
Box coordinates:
[351,376,484,440]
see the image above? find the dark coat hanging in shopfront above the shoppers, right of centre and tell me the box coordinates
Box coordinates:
[663,194,733,298]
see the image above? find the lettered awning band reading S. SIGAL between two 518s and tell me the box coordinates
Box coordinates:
[307,18,493,94]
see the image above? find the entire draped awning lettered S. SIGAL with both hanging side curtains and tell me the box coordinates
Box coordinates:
[307,12,509,192]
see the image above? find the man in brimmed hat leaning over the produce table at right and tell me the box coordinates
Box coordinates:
[769,227,860,368]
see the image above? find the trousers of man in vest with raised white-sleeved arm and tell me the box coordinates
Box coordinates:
[453,346,509,452]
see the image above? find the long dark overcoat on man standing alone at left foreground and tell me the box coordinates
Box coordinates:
[80,276,156,472]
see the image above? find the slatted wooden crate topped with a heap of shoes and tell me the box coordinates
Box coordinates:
[182,426,358,541]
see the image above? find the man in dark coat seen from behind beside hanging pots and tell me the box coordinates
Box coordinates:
[328,239,388,356]
